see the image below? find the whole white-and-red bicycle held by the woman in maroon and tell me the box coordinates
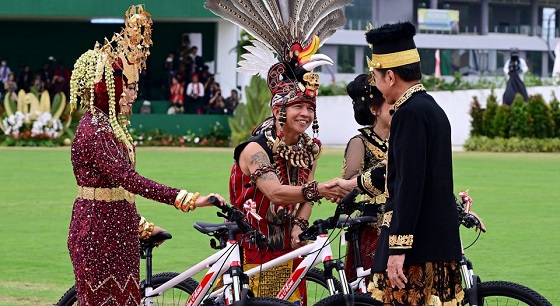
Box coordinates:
[57,198,293,306]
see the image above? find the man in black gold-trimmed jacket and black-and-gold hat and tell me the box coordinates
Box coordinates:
[366,22,463,305]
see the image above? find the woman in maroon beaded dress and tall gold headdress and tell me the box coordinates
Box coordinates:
[68,6,225,305]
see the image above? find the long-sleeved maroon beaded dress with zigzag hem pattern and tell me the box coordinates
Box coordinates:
[68,108,179,305]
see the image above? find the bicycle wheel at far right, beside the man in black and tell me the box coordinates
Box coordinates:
[465,281,552,306]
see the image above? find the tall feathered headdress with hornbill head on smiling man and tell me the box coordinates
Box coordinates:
[204,0,352,106]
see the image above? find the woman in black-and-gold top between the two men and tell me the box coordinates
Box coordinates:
[342,74,391,283]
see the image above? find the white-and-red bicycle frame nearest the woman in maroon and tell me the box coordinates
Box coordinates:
[141,240,241,306]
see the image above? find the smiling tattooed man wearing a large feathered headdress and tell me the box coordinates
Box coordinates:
[205,0,351,305]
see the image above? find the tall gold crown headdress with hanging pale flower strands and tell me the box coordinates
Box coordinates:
[70,5,152,150]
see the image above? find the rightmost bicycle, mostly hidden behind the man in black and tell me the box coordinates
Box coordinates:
[316,192,552,306]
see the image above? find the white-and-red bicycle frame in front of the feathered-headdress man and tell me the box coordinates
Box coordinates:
[206,234,350,300]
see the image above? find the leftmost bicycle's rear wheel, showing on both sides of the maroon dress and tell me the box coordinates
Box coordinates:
[52,272,198,306]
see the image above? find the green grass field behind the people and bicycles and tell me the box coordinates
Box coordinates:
[0,148,560,305]
